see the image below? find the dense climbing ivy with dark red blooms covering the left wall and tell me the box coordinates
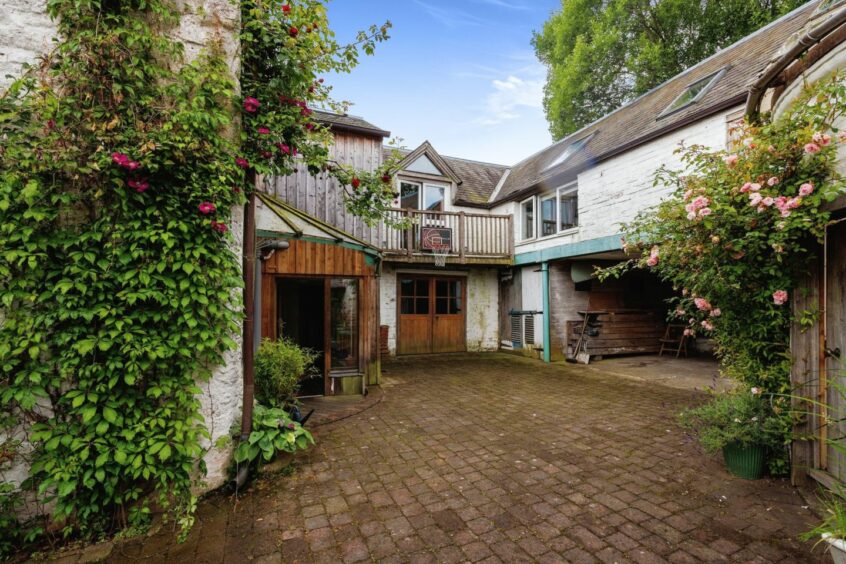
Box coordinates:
[0,0,390,552]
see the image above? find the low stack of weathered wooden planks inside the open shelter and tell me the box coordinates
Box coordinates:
[567,310,666,357]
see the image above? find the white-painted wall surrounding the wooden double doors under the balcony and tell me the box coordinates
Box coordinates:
[379,264,499,355]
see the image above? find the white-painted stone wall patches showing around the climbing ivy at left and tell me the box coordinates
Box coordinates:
[0,0,243,490]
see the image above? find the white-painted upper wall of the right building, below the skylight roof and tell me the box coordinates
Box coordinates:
[504,106,741,254]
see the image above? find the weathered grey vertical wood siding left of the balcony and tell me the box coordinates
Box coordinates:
[264,131,382,246]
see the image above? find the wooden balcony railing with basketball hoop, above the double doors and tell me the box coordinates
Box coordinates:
[379,209,514,264]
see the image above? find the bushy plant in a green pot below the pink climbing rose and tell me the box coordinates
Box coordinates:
[680,388,778,480]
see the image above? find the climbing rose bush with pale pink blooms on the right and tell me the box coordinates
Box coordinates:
[602,73,846,470]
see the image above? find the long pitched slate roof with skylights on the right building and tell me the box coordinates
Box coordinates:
[496,0,819,202]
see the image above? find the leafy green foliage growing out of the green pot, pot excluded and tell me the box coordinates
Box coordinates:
[679,388,783,454]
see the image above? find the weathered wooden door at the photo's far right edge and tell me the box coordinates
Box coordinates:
[820,223,846,481]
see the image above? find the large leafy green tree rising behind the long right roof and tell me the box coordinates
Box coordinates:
[532,0,804,139]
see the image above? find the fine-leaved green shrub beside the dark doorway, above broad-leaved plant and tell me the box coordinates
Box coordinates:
[255,338,317,407]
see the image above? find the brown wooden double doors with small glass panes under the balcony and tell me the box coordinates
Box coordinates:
[397,274,467,354]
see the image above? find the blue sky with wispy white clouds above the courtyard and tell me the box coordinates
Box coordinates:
[327,0,561,165]
